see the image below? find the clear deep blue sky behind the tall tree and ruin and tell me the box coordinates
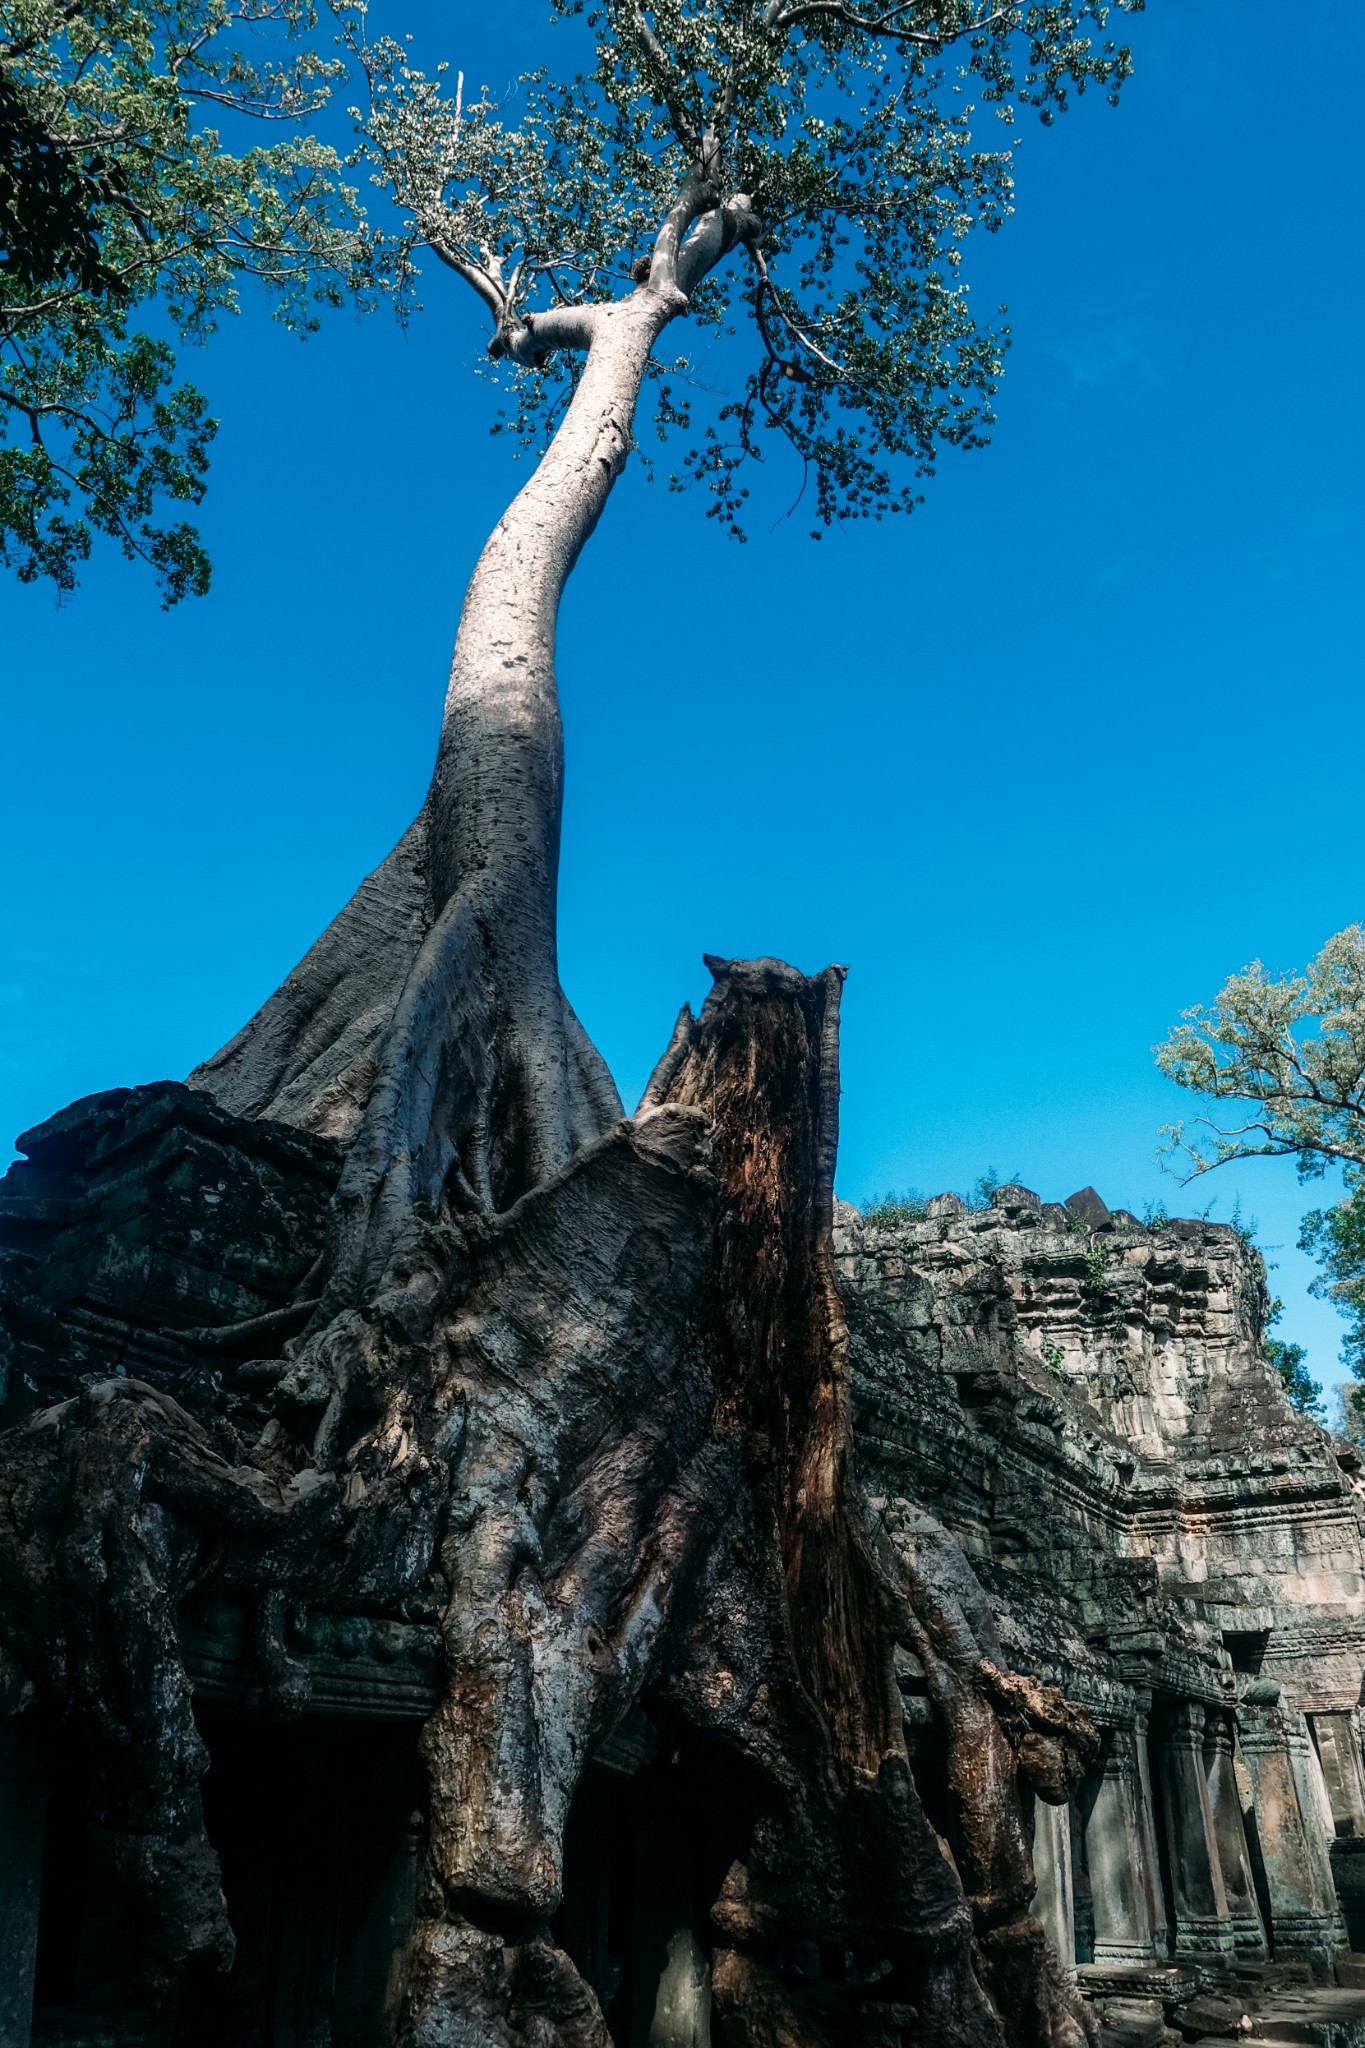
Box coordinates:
[0,0,1365,1378]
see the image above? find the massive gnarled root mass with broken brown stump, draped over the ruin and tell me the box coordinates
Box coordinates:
[0,961,1093,2048]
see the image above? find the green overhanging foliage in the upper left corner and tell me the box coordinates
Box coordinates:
[0,0,377,604]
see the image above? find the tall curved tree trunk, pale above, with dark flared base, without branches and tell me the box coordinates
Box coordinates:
[190,289,677,1261]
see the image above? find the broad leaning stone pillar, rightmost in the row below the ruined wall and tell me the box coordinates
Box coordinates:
[1238,1681,1347,1970]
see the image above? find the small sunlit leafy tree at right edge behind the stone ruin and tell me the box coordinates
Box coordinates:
[1154,924,1365,1419]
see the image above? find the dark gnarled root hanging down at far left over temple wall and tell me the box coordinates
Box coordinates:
[0,1380,304,1978]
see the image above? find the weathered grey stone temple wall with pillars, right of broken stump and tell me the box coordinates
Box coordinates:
[837,1186,1365,2038]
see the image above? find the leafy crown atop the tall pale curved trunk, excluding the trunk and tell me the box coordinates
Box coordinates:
[334,0,1144,539]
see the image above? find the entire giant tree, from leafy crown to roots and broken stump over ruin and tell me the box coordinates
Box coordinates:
[0,0,1138,2048]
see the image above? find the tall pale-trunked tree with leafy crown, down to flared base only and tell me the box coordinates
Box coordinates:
[199,0,1130,1284]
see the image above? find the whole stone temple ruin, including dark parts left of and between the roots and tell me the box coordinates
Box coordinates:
[0,1083,1365,2048]
